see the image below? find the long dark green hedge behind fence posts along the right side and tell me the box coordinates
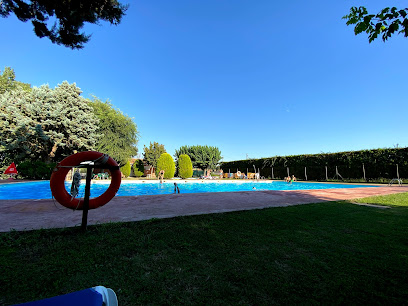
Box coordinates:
[221,148,408,181]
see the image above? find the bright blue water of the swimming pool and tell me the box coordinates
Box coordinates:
[0,180,375,200]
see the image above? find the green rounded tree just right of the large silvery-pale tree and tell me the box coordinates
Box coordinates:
[89,98,138,165]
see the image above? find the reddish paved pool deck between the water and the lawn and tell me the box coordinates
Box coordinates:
[0,180,408,232]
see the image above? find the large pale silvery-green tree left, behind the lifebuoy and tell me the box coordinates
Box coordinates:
[0,82,99,162]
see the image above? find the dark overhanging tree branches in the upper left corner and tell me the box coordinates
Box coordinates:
[0,0,128,49]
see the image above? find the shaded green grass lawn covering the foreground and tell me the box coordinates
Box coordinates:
[0,194,408,305]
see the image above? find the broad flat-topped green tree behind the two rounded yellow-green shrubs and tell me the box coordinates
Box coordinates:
[176,145,222,170]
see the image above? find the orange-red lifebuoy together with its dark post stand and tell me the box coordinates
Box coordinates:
[50,151,121,231]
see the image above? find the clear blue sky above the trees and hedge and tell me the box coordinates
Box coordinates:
[0,0,408,161]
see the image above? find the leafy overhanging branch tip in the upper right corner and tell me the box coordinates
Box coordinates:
[343,6,408,43]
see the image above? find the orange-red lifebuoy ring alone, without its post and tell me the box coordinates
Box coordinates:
[50,151,121,210]
